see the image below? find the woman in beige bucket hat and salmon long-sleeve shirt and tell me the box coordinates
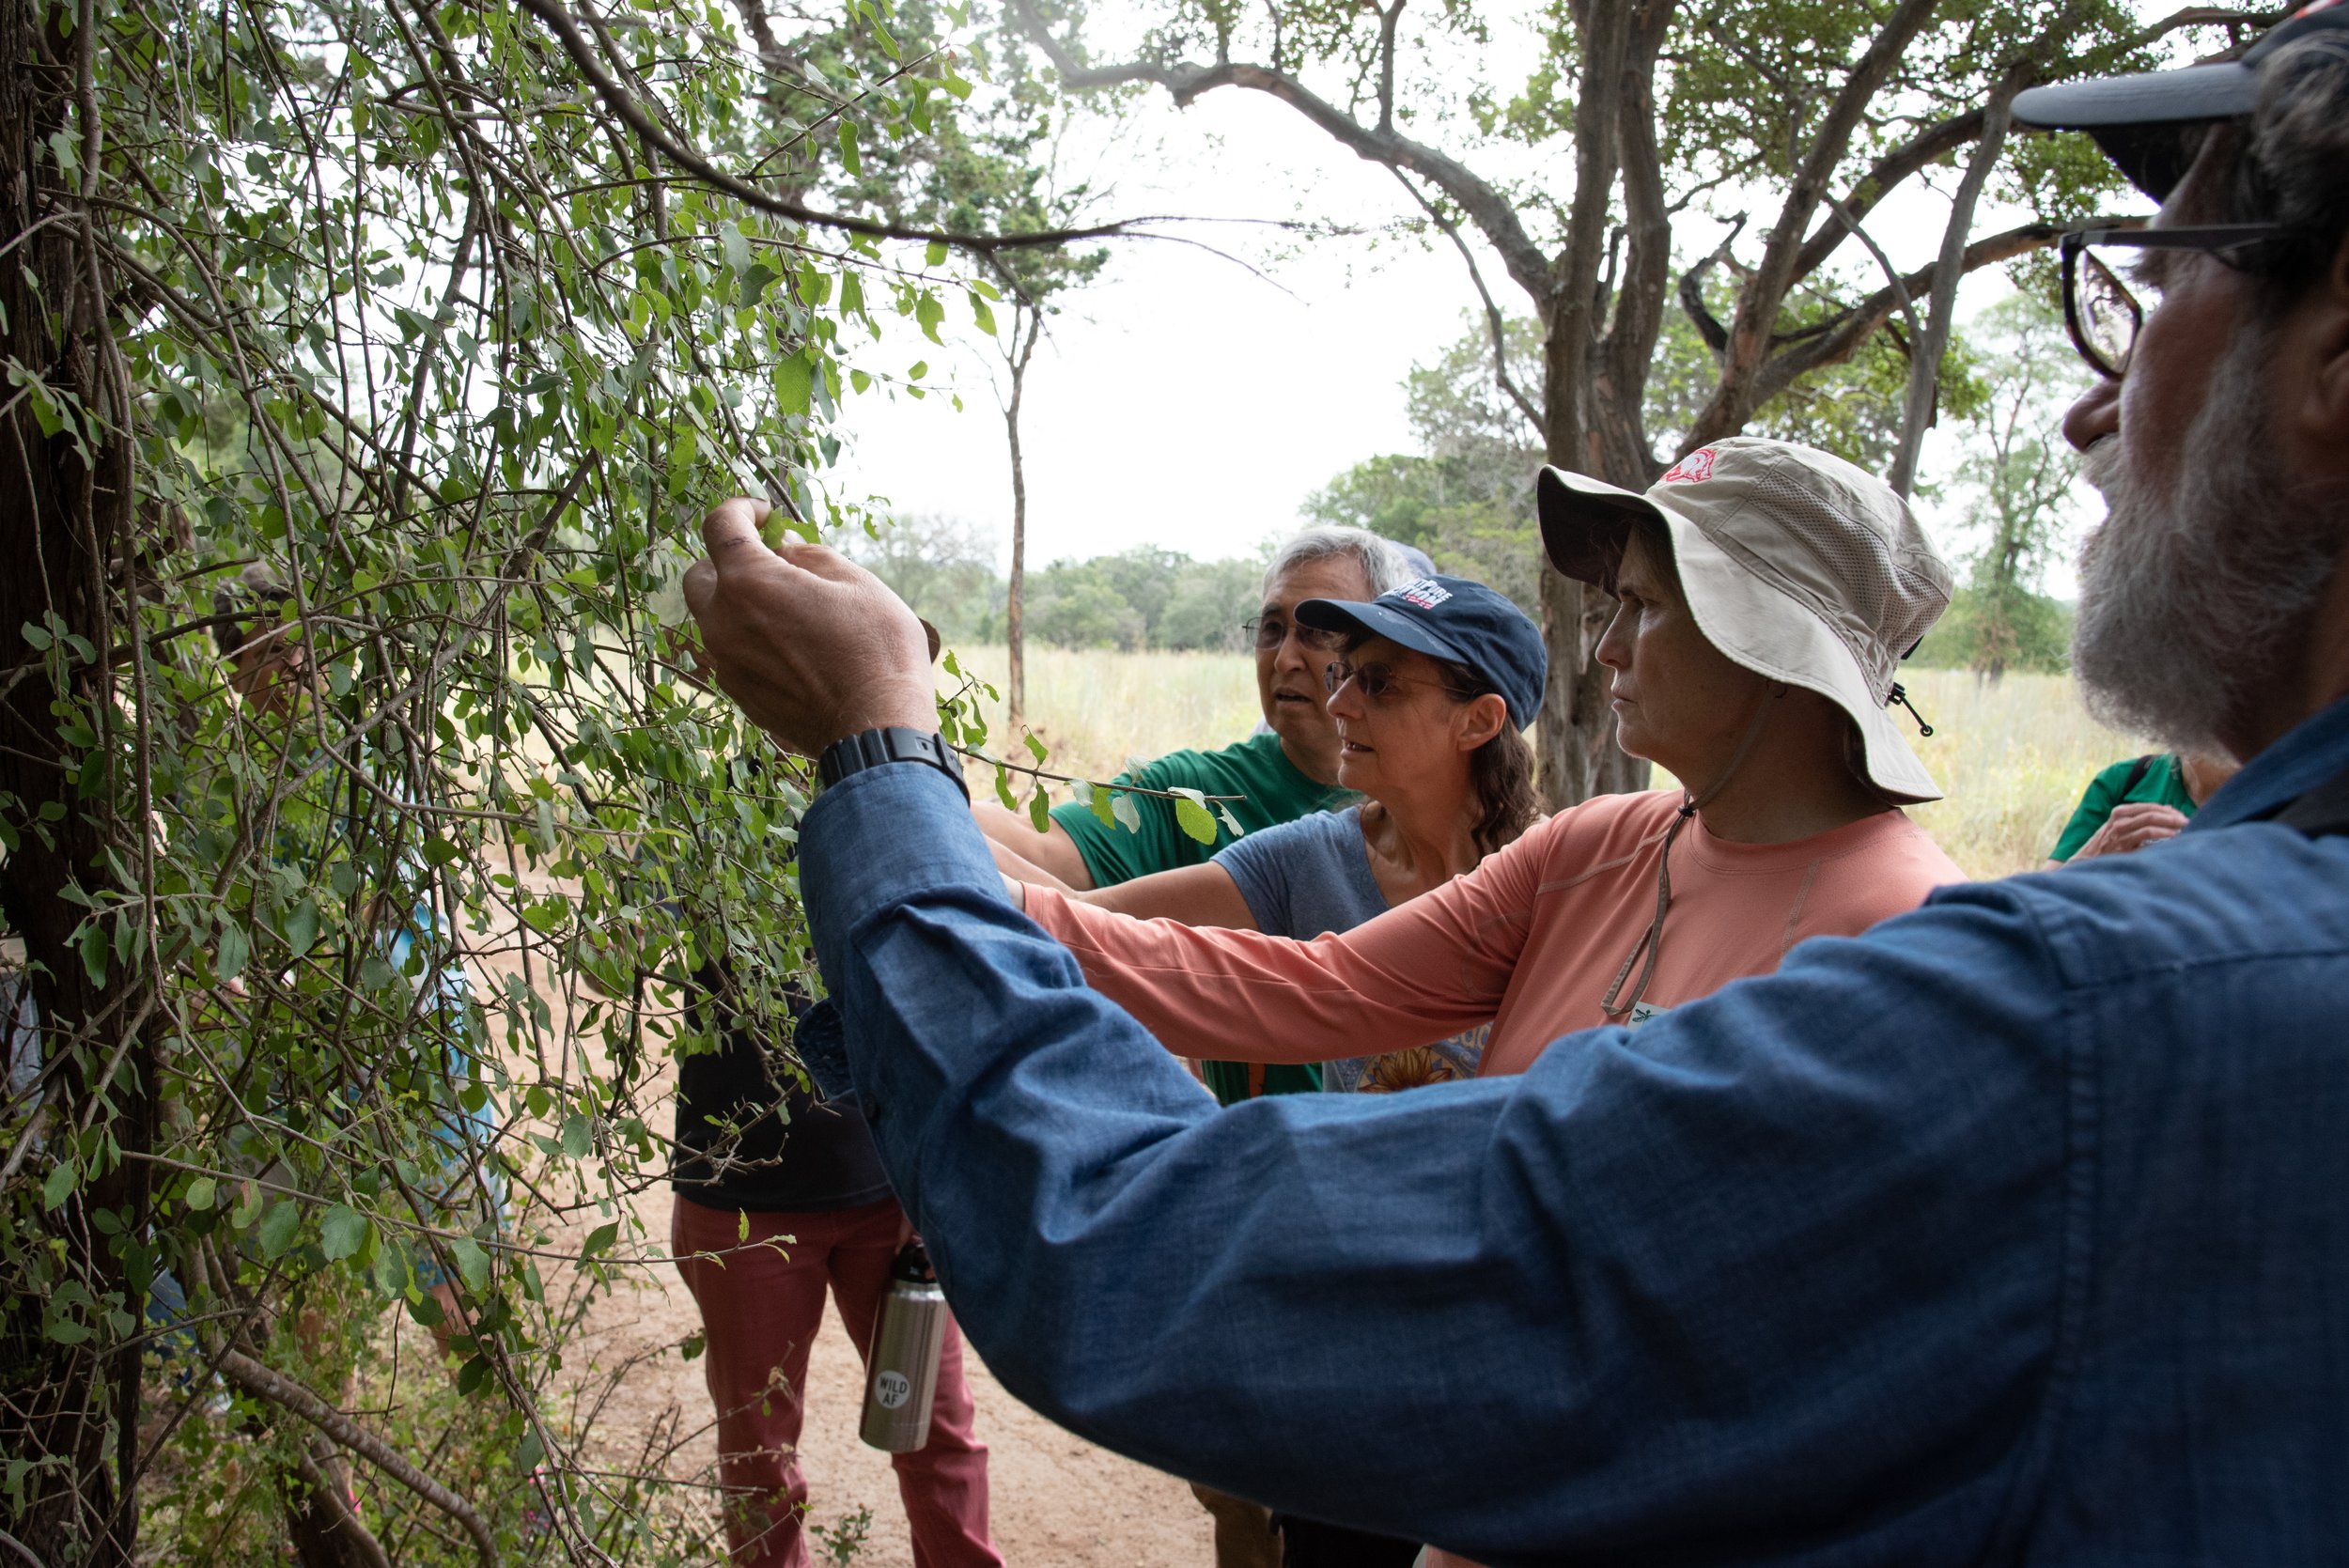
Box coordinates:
[1027,437,1964,1075]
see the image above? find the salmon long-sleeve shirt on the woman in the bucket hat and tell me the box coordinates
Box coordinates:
[1027,791,1964,1078]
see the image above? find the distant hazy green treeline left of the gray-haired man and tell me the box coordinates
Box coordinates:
[850,517,1264,653]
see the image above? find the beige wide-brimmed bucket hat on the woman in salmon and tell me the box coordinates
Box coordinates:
[1536,437,1950,800]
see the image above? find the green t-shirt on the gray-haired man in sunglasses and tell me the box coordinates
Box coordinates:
[1052,735,1353,1106]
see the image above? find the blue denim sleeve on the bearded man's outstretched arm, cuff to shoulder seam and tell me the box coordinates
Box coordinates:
[801,768,2079,1568]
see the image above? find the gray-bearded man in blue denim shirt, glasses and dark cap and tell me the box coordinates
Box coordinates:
[689,7,2349,1568]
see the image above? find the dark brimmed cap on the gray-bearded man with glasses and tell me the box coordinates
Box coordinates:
[2015,0,2349,202]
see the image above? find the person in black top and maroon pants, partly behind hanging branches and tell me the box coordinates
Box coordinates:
[670,970,1003,1568]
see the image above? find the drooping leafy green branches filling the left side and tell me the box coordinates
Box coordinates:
[0,0,996,1561]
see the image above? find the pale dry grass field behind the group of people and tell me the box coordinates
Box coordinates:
[958,648,2145,877]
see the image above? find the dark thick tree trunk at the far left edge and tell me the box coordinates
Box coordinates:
[0,0,155,1563]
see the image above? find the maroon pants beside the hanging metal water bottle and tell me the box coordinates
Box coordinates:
[670,1197,1003,1568]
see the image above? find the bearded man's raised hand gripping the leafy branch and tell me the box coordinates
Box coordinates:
[686,495,938,756]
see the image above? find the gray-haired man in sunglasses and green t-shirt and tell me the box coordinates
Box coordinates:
[971,528,1412,1106]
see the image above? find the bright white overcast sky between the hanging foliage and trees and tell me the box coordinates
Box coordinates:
[834,16,2161,592]
